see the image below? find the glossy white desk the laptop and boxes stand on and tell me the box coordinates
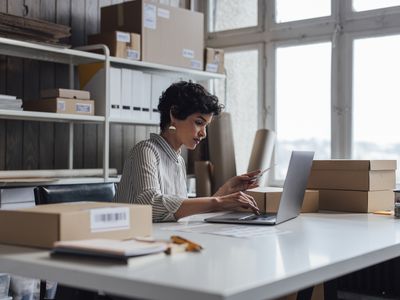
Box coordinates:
[0,214,400,300]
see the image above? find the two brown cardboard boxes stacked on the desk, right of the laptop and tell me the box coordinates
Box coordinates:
[308,160,396,213]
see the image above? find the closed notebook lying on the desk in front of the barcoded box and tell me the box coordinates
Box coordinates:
[52,239,168,262]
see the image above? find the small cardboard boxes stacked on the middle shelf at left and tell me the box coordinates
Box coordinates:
[23,89,94,115]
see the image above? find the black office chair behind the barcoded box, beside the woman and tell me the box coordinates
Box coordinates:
[33,182,116,300]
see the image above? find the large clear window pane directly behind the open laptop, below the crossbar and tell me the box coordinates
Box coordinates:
[275,43,331,180]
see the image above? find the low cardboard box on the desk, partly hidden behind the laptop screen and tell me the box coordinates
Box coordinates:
[246,187,319,213]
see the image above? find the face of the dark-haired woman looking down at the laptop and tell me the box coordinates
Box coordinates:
[174,113,213,150]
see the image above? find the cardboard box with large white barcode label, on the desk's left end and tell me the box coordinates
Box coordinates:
[0,202,152,248]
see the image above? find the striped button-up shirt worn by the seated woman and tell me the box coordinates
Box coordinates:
[115,133,187,222]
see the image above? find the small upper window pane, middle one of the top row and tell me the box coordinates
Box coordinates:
[275,0,331,23]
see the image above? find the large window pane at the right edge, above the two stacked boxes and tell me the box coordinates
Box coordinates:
[353,35,400,178]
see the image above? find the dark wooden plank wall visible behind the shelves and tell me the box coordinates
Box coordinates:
[0,0,158,172]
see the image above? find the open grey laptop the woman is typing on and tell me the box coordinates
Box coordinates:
[204,151,314,225]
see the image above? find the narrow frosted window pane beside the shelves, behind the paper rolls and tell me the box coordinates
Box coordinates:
[216,50,258,174]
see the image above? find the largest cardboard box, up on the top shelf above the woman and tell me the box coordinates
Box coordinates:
[101,0,204,70]
